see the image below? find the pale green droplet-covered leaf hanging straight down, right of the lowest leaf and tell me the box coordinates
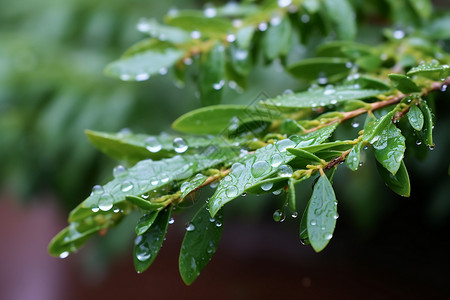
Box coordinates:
[300,175,338,252]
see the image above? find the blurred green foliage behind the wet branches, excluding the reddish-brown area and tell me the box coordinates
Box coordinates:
[0,0,450,290]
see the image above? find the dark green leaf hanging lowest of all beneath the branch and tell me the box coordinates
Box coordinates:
[179,205,223,285]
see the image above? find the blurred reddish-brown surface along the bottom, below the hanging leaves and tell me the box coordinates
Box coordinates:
[0,192,449,300]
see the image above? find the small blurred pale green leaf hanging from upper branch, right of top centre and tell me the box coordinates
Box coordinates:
[262,18,292,61]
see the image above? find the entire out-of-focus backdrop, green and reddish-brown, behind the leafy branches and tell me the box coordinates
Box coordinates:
[0,0,450,299]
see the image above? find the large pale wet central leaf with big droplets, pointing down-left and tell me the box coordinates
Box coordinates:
[209,124,337,216]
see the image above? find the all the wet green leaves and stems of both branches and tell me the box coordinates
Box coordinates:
[49,0,450,284]
